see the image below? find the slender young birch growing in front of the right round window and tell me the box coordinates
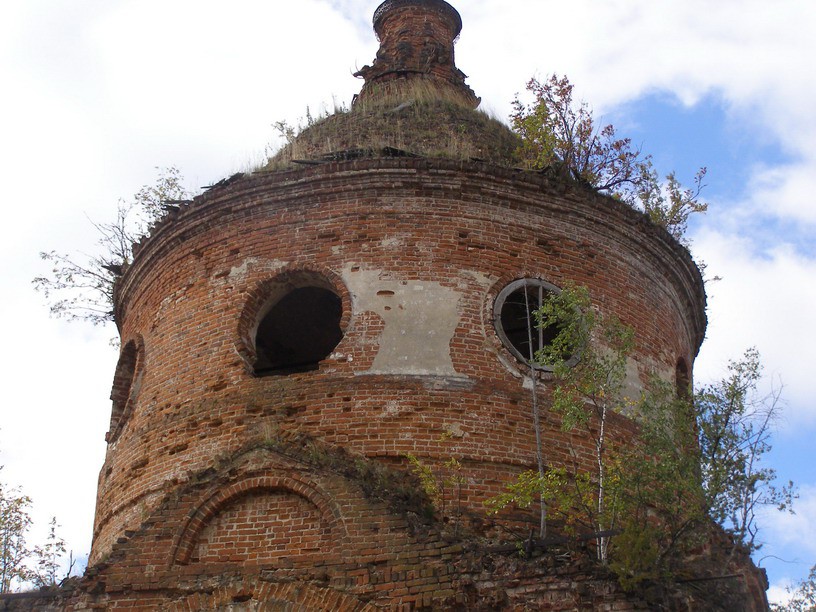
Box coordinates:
[490,286,634,563]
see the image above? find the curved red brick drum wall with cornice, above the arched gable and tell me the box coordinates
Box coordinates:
[87,159,705,562]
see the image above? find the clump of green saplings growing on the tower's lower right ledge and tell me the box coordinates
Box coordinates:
[487,287,793,589]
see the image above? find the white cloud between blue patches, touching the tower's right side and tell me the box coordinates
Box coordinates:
[694,230,816,425]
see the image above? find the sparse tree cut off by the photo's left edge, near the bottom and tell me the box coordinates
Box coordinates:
[0,482,31,593]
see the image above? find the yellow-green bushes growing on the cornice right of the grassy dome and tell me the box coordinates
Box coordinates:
[510,74,708,246]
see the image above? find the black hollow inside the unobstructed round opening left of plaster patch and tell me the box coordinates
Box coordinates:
[255,287,343,374]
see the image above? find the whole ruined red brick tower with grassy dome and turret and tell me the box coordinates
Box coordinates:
[9,0,768,610]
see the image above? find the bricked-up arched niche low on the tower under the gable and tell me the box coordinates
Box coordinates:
[173,477,345,565]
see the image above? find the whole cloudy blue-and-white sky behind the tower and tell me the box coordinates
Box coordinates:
[0,0,816,596]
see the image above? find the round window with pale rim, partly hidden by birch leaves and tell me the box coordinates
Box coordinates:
[493,278,578,372]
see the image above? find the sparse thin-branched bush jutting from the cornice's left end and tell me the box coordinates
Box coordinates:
[32,167,189,325]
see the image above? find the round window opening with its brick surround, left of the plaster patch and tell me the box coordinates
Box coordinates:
[238,268,351,376]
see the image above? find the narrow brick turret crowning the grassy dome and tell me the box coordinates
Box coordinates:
[355,0,480,108]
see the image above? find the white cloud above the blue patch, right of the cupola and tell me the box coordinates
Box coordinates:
[460,0,816,122]
